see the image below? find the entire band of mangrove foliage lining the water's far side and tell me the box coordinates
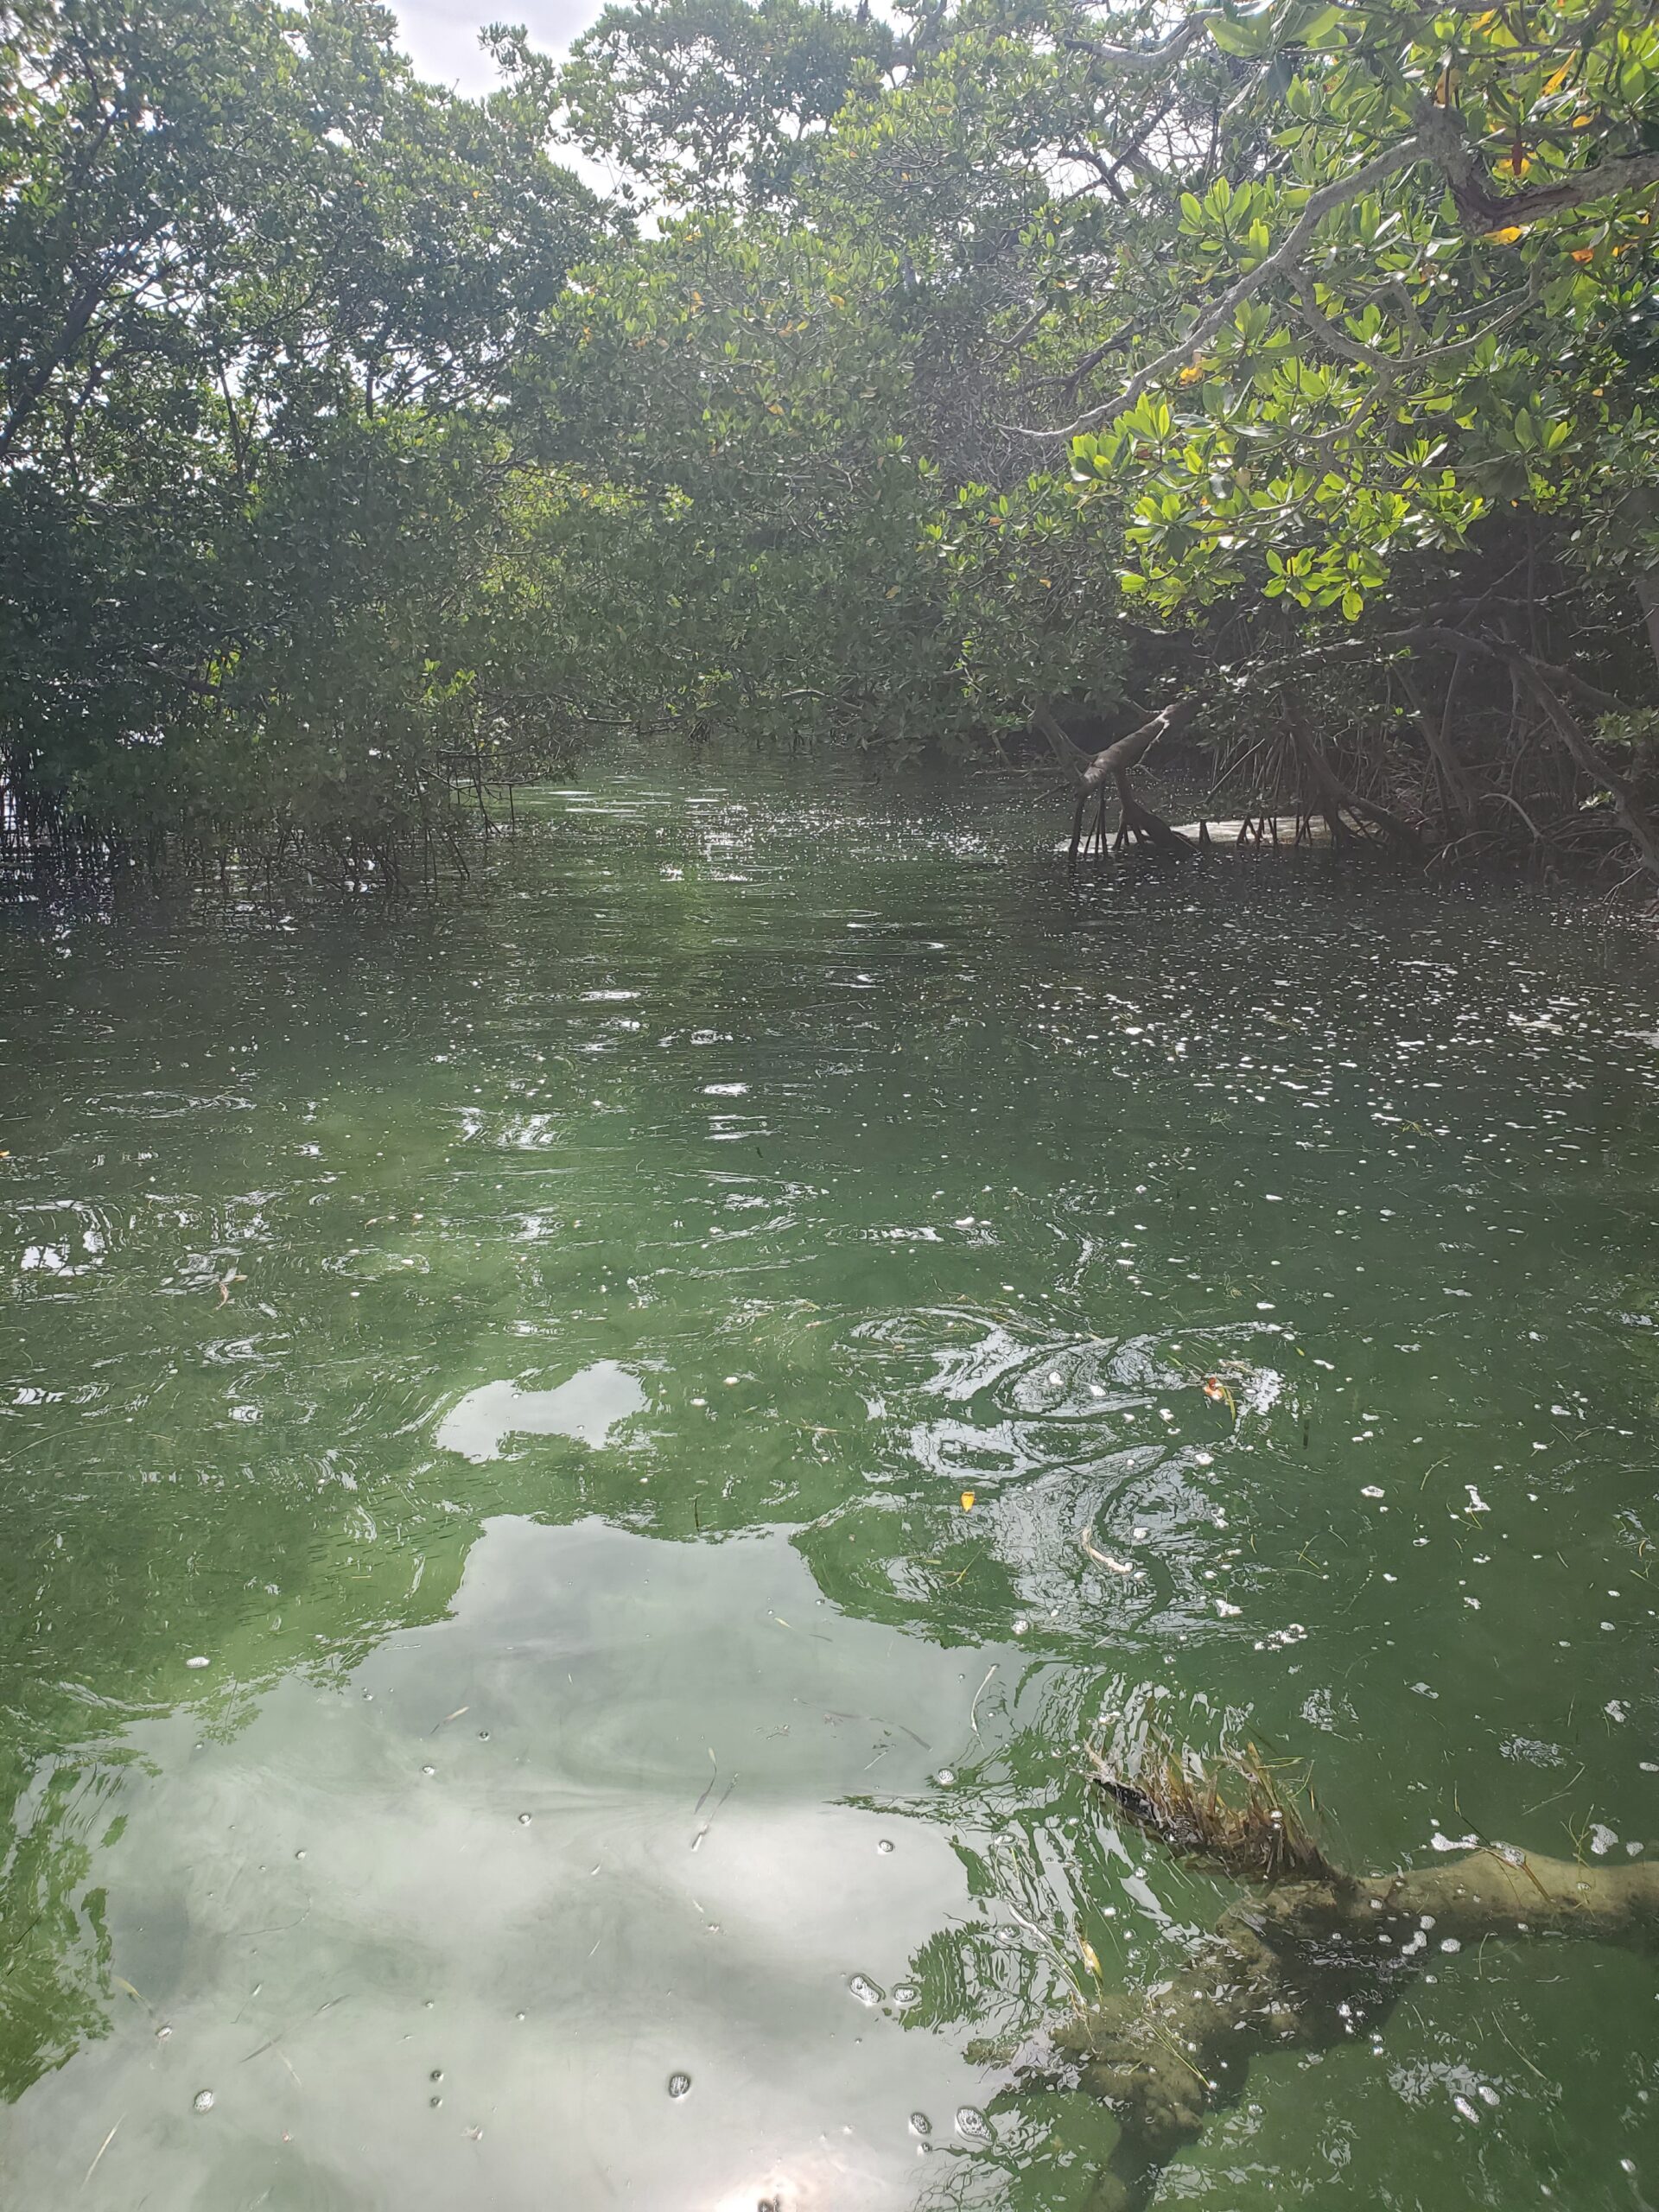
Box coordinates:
[0,0,1659,868]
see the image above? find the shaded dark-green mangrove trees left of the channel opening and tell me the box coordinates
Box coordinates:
[0,0,601,867]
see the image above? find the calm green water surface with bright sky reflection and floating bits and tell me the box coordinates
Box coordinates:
[0,761,1659,2212]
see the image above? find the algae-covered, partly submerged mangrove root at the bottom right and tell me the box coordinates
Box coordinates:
[986,1754,1659,2212]
